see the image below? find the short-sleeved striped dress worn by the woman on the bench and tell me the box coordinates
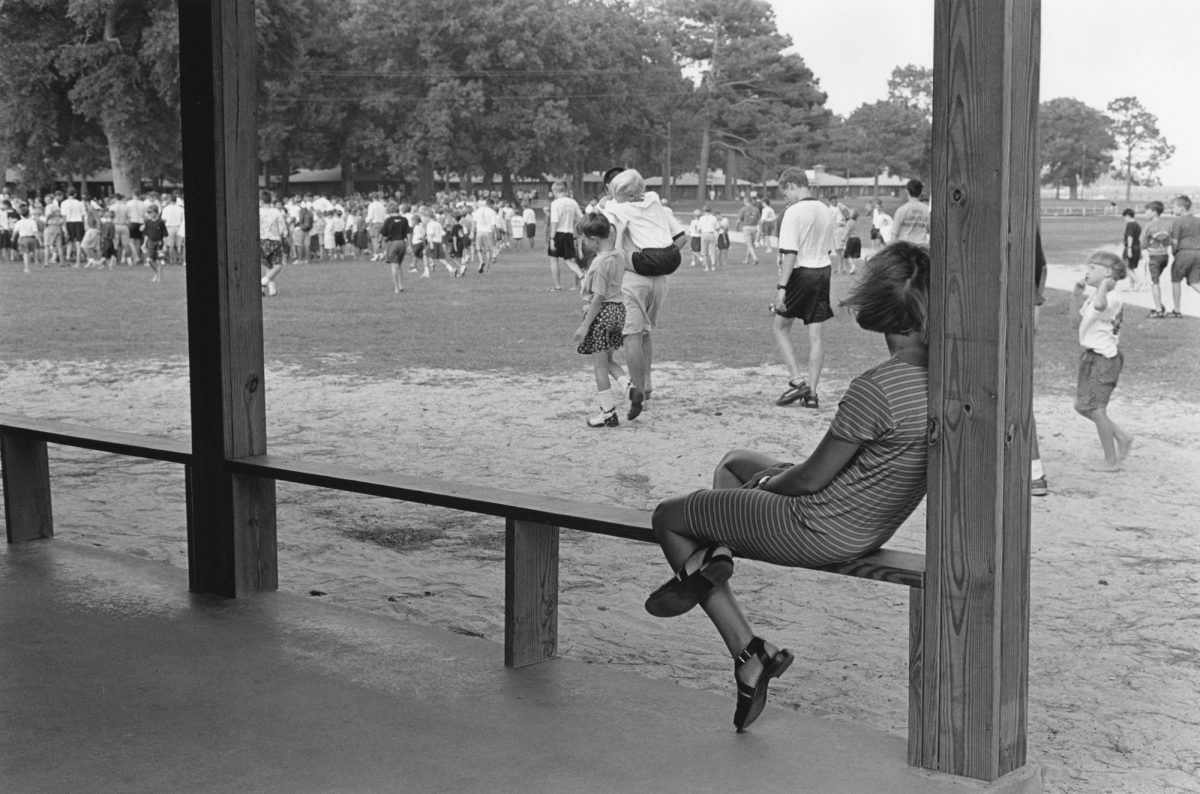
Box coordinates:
[684,359,929,567]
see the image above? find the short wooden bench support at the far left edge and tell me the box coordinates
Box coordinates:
[0,433,54,543]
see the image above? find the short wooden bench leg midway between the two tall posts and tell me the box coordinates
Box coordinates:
[504,518,558,667]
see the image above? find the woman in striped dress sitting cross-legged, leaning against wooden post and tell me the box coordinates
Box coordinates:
[646,242,929,730]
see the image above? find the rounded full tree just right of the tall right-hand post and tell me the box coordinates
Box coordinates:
[1038,97,1117,199]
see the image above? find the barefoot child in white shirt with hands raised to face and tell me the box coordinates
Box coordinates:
[1072,251,1133,471]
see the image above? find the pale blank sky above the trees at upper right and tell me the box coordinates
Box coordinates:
[770,0,1200,186]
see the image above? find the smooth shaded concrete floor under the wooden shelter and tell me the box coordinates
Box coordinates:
[0,541,1040,794]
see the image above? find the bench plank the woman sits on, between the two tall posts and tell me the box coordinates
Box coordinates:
[229,455,925,588]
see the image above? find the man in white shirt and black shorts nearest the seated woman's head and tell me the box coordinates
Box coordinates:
[772,167,836,408]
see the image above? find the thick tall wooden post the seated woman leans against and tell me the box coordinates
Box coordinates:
[912,0,1040,781]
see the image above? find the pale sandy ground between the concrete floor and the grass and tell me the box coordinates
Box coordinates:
[0,326,1200,793]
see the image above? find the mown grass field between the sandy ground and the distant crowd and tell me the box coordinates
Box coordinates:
[0,217,1200,400]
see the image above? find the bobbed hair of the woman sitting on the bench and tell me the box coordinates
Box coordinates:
[841,242,929,341]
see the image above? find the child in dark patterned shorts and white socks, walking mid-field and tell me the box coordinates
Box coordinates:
[575,212,626,427]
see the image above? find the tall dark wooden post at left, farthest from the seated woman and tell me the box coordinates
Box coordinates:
[179,0,277,596]
